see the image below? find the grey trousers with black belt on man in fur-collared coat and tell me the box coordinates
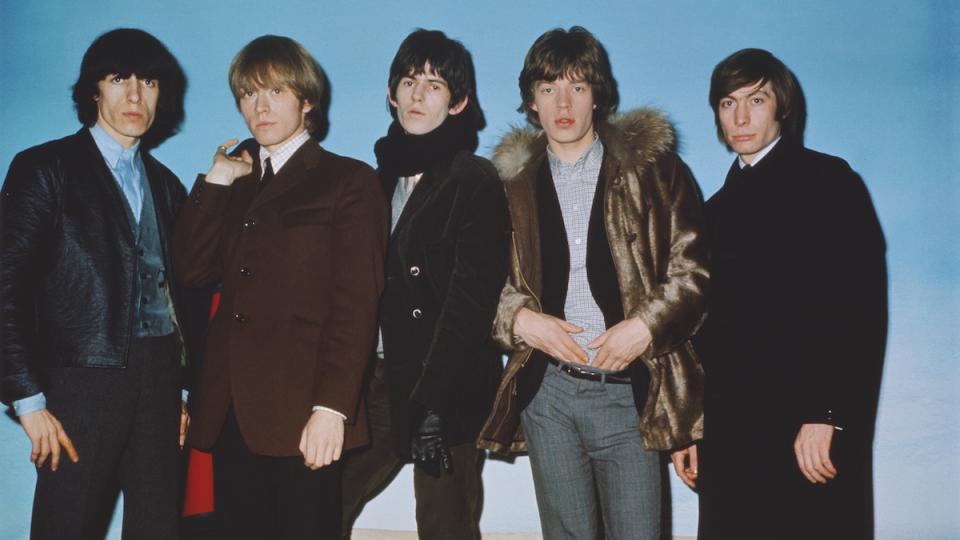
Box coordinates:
[522,365,661,540]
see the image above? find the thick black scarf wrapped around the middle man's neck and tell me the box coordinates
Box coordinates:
[373,114,478,178]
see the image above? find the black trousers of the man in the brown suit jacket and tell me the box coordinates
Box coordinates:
[213,409,340,540]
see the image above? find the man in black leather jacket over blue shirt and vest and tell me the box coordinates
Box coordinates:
[0,29,193,538]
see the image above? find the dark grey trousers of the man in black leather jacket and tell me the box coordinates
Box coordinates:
[30,335,180,539]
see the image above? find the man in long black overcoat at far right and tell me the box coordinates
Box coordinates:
[674,49,887,539]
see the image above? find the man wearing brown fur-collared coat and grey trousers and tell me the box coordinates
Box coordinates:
[480,27,708,540]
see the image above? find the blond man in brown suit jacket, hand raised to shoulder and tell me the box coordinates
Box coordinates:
[174,36,387,539]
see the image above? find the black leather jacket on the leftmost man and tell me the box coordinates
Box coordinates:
[0,128,186,403]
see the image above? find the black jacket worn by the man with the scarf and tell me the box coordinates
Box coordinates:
[380,151,510,456]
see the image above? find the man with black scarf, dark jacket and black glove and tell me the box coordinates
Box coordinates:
[343,30,509,540]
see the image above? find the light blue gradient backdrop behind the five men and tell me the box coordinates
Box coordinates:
[0,0,960,539]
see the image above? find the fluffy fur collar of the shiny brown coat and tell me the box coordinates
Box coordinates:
[493,107,677,182]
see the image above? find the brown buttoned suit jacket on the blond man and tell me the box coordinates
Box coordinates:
[173,140,387,456]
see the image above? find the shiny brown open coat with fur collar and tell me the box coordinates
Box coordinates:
[477,109,708,453]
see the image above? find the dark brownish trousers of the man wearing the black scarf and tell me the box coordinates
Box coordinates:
[343,361,484,540]
